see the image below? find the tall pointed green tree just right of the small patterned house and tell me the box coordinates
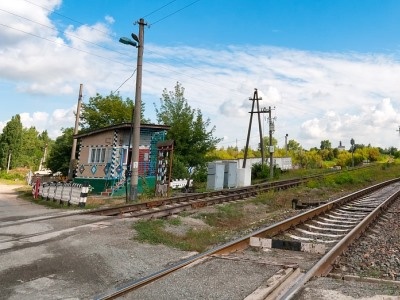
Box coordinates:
[154,82,221,182]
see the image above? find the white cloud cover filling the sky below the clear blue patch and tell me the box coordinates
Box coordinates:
[0,0,400,148]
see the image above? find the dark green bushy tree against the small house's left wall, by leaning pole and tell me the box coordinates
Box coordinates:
[47,127,74,176]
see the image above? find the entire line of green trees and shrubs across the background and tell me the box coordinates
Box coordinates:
[0,82,400,180]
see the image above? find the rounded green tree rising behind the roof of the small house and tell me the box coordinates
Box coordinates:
[80,93,149,131]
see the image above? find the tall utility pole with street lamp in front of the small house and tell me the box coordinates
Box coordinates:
[129,19,146,201]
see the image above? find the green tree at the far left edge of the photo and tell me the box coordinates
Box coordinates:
[0,114,23,170]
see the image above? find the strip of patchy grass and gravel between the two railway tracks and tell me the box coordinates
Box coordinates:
[133,164,400,252]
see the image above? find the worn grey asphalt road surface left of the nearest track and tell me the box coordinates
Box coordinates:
[0,185,187,300]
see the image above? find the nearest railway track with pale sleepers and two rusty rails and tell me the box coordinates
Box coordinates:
[96,179,400,299]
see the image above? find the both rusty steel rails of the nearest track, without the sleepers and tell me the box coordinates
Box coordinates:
[95,178,400,300]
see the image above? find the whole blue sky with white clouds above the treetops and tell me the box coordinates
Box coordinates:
[0,0,400,149]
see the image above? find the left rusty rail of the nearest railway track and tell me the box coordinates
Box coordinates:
[94,178,400,300]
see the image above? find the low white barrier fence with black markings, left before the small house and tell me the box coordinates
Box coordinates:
[32,182,89,206]
